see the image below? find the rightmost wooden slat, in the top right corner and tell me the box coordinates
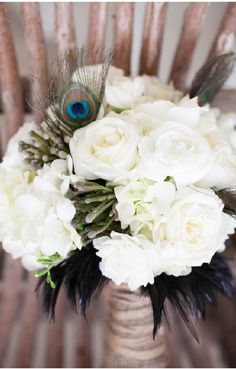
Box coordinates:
[209,3,236,58]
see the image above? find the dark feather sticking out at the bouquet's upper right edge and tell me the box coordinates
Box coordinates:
[189,52,236,105]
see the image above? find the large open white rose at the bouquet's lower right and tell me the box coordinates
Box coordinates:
[156,187,236,276]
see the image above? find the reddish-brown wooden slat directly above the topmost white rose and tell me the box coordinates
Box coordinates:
[114,3,134,75]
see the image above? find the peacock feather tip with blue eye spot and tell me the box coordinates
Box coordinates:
[35,46,113,133]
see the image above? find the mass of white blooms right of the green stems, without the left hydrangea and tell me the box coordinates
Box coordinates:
[70,68,236,290]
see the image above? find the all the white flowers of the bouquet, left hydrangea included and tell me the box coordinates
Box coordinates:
[0,67,236,290]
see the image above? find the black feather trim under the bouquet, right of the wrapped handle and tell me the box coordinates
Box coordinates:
[141,254,232,341]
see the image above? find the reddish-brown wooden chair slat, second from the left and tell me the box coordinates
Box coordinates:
[21,3,48,123]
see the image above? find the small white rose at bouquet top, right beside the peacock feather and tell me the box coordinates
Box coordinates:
[105,76,145,109]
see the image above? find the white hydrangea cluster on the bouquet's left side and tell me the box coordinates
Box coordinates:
[0,123,82,270]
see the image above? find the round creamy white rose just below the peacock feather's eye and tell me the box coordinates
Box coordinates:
[70,114,139,180]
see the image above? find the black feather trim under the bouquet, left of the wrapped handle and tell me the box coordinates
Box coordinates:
[38,247,109,318]
